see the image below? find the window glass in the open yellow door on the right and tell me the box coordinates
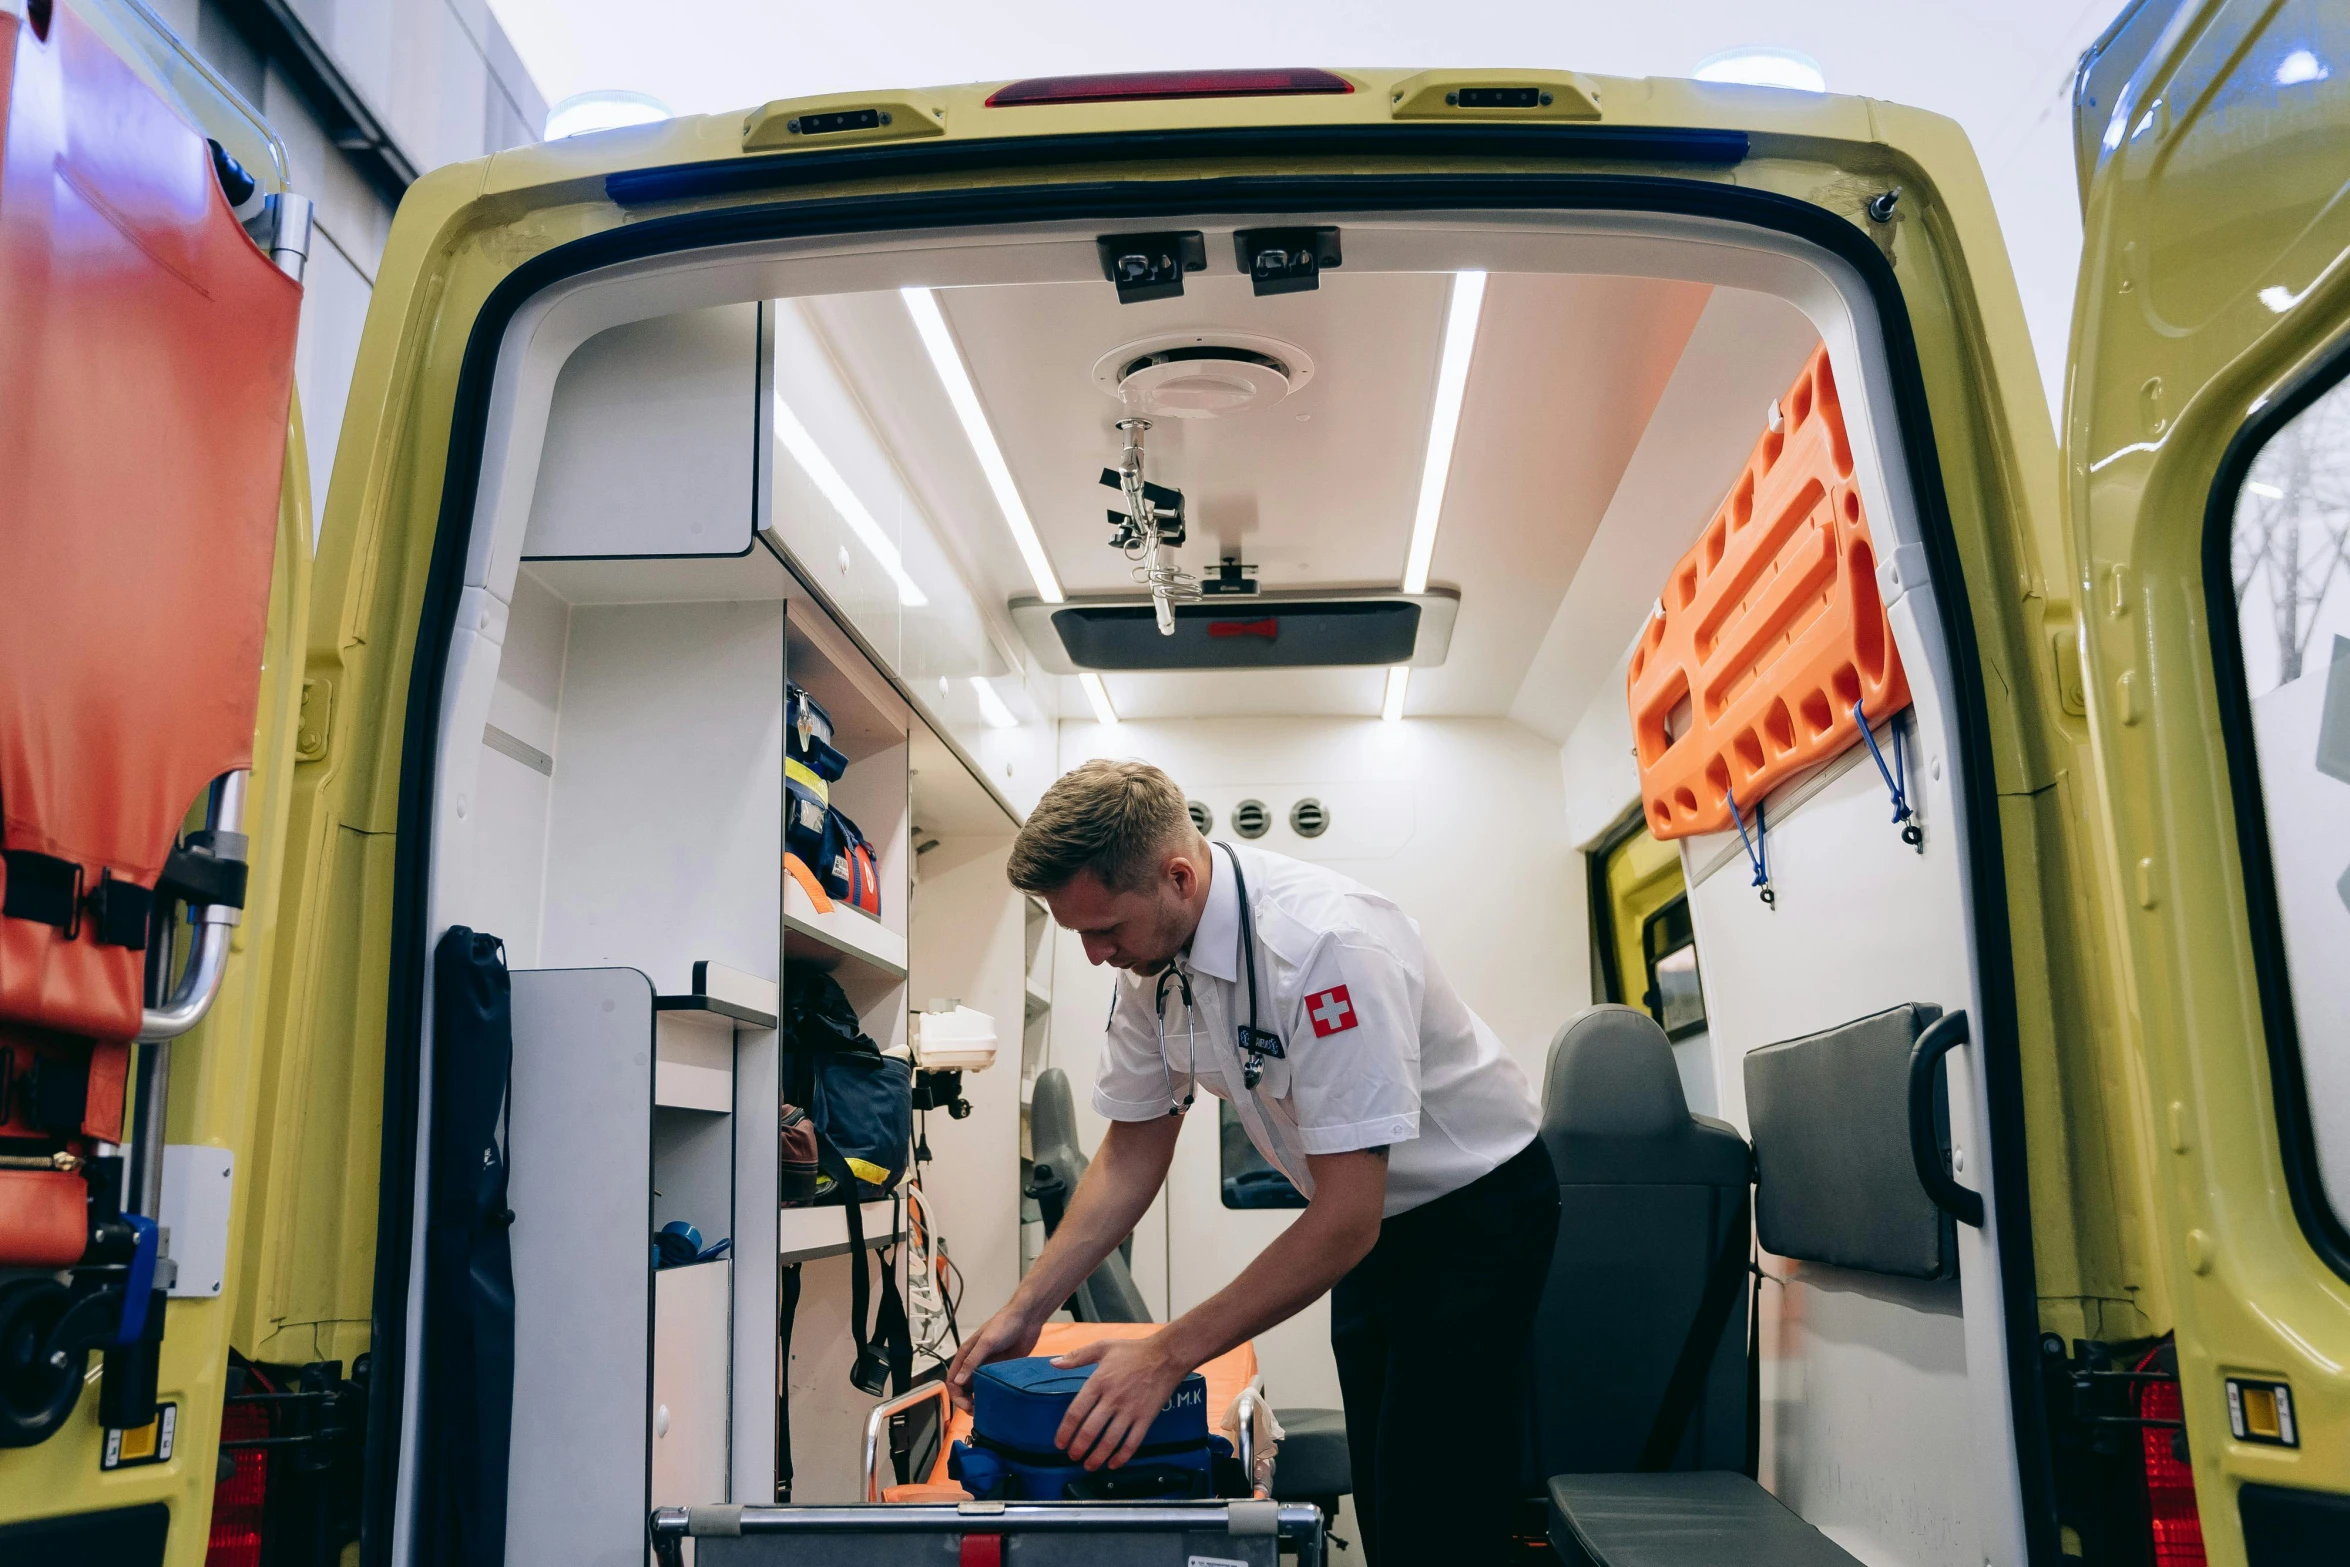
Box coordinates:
[2228,381,2350,1212]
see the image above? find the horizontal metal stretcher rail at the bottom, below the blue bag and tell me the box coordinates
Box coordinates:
[651,1501,1323,1567]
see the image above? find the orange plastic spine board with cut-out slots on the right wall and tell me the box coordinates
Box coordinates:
[1626,345,1911,839]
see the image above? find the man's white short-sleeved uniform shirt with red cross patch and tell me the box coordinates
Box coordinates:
[1093,843,1539,1217]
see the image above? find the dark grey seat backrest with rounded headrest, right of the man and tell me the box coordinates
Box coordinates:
[1528,1006,1753,1487]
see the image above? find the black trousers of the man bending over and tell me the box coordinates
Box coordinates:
[1330,1137,1558,1567]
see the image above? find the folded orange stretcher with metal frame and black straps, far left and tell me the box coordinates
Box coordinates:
[0,0,301,1447]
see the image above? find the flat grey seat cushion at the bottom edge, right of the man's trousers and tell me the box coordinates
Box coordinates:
[1551,1471,1859,1567]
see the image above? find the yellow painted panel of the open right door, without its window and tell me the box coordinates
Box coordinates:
[2066,0,2350,1567]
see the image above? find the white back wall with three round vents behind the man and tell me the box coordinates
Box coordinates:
[1053,719,1589,1407]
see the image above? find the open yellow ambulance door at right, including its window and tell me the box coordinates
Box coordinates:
[2066,0,2350,1567]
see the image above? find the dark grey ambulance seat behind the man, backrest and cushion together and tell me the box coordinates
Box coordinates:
[1528,1006,1859,1567]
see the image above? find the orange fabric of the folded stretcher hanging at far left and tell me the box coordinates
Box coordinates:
[0,5,301,1041]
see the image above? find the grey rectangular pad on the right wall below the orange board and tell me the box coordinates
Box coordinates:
[1746,1006,1958,1278]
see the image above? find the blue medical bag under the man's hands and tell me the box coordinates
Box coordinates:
[947,1356,1246,1501]
